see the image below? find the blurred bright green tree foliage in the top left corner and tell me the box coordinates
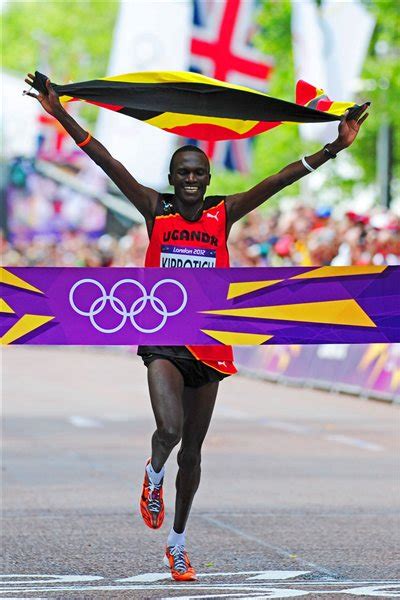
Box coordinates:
[2,0,118,121]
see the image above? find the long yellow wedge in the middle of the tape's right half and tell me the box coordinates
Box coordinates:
[200,299,376,327]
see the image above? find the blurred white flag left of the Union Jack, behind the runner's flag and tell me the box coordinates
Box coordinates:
[96,0,192,189]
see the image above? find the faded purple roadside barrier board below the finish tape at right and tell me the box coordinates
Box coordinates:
[235,344,400,402]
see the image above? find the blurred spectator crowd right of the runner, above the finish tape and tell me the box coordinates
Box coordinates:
[231,203,400,267]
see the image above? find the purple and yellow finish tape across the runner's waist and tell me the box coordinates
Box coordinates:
[0,259,400,346]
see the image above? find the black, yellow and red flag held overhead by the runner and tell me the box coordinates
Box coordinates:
[29,71,355,141]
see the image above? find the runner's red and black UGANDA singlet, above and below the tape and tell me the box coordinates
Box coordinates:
[139,194,236,374]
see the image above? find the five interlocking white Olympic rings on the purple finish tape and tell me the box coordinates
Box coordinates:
[69,279,187,333]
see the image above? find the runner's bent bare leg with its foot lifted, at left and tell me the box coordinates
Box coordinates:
[147,359,184,472]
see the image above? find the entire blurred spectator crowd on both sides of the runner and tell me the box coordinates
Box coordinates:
[1,203,400,267]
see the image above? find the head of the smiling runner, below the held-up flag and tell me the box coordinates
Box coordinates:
[169,151,211,204]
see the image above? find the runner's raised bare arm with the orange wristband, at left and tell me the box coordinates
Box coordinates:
[25,73,158,221]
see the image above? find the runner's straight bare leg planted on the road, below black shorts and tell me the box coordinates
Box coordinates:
[173,381,219,533]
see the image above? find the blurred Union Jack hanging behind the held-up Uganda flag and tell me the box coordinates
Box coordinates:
[190,0,272,172]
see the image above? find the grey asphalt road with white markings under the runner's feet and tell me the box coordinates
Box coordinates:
[0,346,400,600]
